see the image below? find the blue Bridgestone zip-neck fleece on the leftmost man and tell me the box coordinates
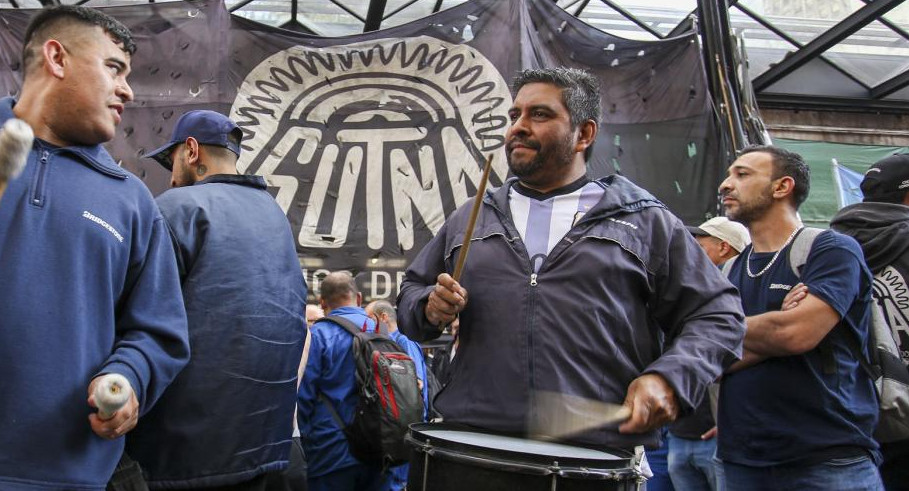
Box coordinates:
[0,98,189,490]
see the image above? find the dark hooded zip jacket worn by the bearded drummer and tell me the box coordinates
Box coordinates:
[398,176,745,448]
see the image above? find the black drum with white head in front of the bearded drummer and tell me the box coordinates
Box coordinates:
[406,423,644,491]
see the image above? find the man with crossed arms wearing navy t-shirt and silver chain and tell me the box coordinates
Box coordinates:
[718,146,881,491]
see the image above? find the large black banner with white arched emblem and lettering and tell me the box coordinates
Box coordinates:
[0,0,726,298]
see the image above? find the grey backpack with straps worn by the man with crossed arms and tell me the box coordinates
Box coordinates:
[723,227,909,443]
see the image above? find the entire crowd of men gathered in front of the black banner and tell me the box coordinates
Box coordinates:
[0,6,909,491]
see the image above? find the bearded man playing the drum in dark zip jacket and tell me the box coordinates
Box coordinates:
[398,68,744,468]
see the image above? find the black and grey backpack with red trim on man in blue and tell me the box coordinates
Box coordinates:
[319,315,423,467]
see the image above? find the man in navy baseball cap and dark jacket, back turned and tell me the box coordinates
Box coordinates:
[127,111,306,490]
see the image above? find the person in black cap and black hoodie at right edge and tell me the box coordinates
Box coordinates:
[830,153,909,490]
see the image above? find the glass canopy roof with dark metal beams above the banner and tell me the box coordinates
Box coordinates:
[0,0,909,112]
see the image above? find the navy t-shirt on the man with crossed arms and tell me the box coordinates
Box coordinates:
[718,231,879,466]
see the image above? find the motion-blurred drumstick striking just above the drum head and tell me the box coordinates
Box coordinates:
[528,390,631,440]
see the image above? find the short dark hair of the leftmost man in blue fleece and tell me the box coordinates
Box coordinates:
[22,5,136,72]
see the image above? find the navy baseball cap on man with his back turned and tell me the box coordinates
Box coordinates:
[142,110,243,170]
